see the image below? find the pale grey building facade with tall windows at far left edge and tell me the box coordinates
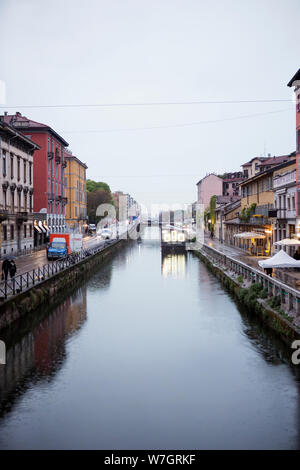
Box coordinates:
[0,120,39,256]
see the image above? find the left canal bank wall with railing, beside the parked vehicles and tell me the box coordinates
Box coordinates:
[0,223,139,331]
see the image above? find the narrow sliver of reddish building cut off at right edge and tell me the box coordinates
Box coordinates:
[288,69,300,235]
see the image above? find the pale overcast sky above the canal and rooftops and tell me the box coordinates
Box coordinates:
[0,0,300,209]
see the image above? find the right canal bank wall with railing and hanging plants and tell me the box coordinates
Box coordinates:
[192,244,300,345]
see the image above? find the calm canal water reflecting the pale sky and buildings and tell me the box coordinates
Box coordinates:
[0,228,300,449]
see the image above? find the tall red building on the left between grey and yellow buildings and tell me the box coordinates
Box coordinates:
[3,112,69,237]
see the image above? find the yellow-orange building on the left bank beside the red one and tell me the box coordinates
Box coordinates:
[65,154,87,233]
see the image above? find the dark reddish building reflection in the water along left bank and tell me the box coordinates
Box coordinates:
[0,287,87,416]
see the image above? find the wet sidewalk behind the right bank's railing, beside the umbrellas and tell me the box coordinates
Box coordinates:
[204,236,300,290]
